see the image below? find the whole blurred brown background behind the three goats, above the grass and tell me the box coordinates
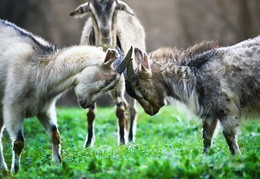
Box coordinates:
[0,0,260,106]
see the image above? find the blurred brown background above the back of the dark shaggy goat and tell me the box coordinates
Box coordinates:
[126,0,260,51]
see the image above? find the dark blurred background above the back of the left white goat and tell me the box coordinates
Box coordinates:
[0,0,84,46]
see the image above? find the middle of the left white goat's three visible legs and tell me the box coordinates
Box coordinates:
[3,104,24,173]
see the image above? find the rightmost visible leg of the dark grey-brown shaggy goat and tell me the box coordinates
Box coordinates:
[220,116,241,154]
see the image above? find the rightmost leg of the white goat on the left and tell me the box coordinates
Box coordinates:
[37,109,61,164]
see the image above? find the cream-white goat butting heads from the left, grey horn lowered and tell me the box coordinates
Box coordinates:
[0,20,132,172]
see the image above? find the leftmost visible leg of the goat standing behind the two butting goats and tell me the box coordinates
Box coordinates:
[85,103,97,147]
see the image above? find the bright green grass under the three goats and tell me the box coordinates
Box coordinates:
[0,107,260,179]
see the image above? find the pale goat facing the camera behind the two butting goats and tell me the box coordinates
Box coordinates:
[70,0,145,147]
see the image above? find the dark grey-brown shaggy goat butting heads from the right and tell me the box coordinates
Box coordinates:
[125,36,260,154]
